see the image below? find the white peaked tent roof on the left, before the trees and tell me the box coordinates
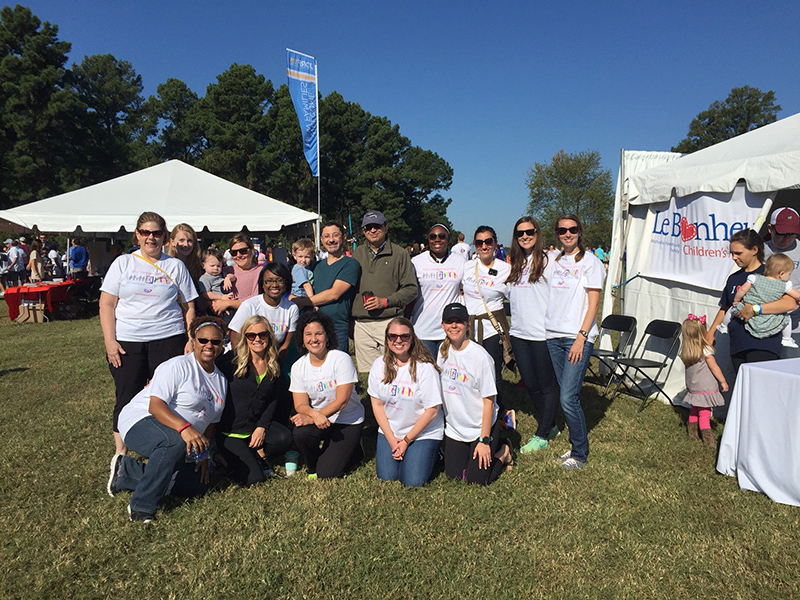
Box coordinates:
[0,160,317,233]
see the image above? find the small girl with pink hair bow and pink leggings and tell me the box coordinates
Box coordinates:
[680,314,728,448]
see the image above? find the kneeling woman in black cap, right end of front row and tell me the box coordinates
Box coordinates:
[438,303,514,485]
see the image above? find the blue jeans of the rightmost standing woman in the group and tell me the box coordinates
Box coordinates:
[547,338,594,462]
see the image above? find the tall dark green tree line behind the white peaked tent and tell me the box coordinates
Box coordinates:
[0,5,453,242]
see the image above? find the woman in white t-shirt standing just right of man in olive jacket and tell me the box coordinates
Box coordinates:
[411,224,466,356]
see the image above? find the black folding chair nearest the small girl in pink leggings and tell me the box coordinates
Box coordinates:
[611,319,681,412]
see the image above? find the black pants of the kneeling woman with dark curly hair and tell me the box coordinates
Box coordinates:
[294,423,364,479]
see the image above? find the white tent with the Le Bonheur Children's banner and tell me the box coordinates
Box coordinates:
[604,114,800,400]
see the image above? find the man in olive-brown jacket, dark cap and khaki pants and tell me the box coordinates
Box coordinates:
[353,210,417,373]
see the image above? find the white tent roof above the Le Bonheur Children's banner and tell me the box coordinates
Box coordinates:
[630,114,800,204]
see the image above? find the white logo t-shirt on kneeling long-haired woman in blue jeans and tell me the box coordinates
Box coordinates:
[367,356,444,440]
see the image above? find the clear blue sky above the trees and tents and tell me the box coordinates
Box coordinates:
[25,0,800,244]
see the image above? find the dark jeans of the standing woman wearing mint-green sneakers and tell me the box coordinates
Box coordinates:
[511,337,558,439]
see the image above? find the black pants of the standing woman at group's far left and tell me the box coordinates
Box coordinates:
[108,333,186,431]
